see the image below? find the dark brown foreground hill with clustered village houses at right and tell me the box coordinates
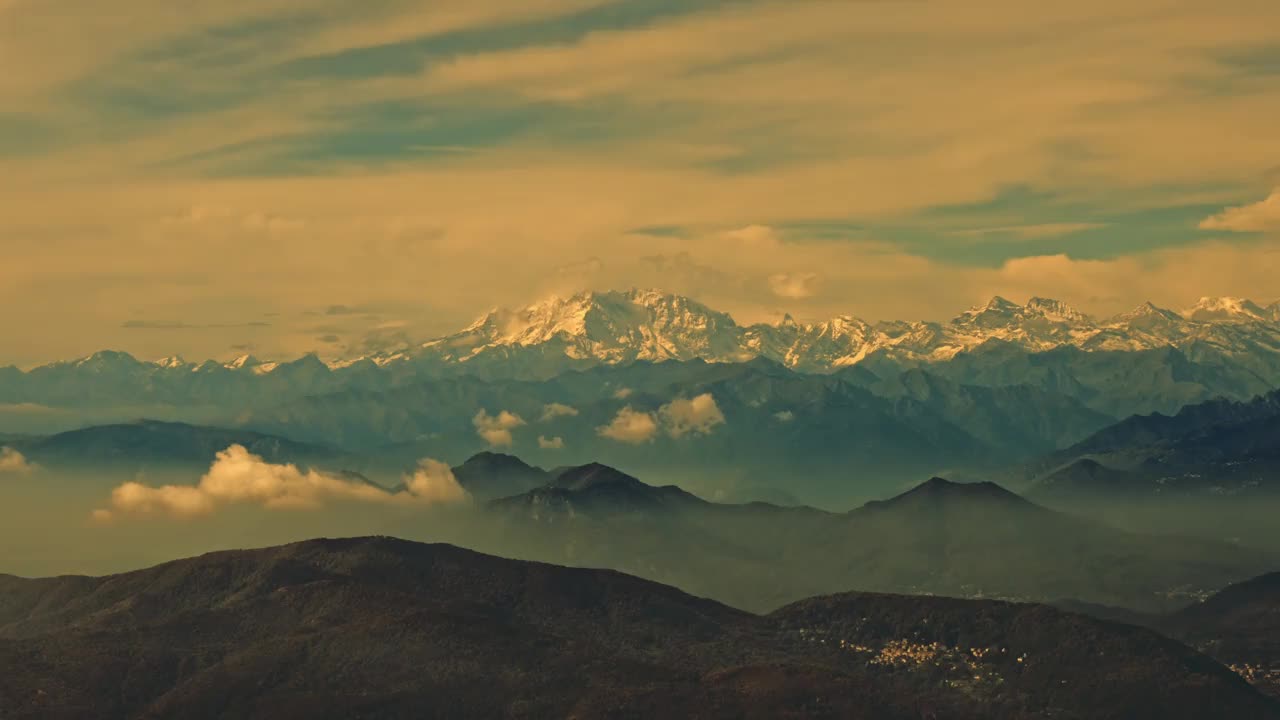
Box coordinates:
[0,538,1280,720]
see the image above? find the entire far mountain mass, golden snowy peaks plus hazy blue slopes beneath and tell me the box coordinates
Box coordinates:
[0,291,1280,497]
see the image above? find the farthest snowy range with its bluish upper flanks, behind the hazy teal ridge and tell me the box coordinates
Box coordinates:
[0,290,1280,416]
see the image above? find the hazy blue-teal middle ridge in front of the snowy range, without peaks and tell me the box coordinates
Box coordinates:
[5,360,1126,506]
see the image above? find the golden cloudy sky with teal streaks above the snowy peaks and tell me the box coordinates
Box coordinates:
[0,0,1280,366]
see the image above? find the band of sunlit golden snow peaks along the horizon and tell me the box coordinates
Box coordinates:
[8,290,1280,377]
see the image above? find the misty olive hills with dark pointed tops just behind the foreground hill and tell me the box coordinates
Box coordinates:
[472,456,1277,611]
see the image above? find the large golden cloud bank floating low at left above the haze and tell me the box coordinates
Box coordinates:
[93,445,467,521]
